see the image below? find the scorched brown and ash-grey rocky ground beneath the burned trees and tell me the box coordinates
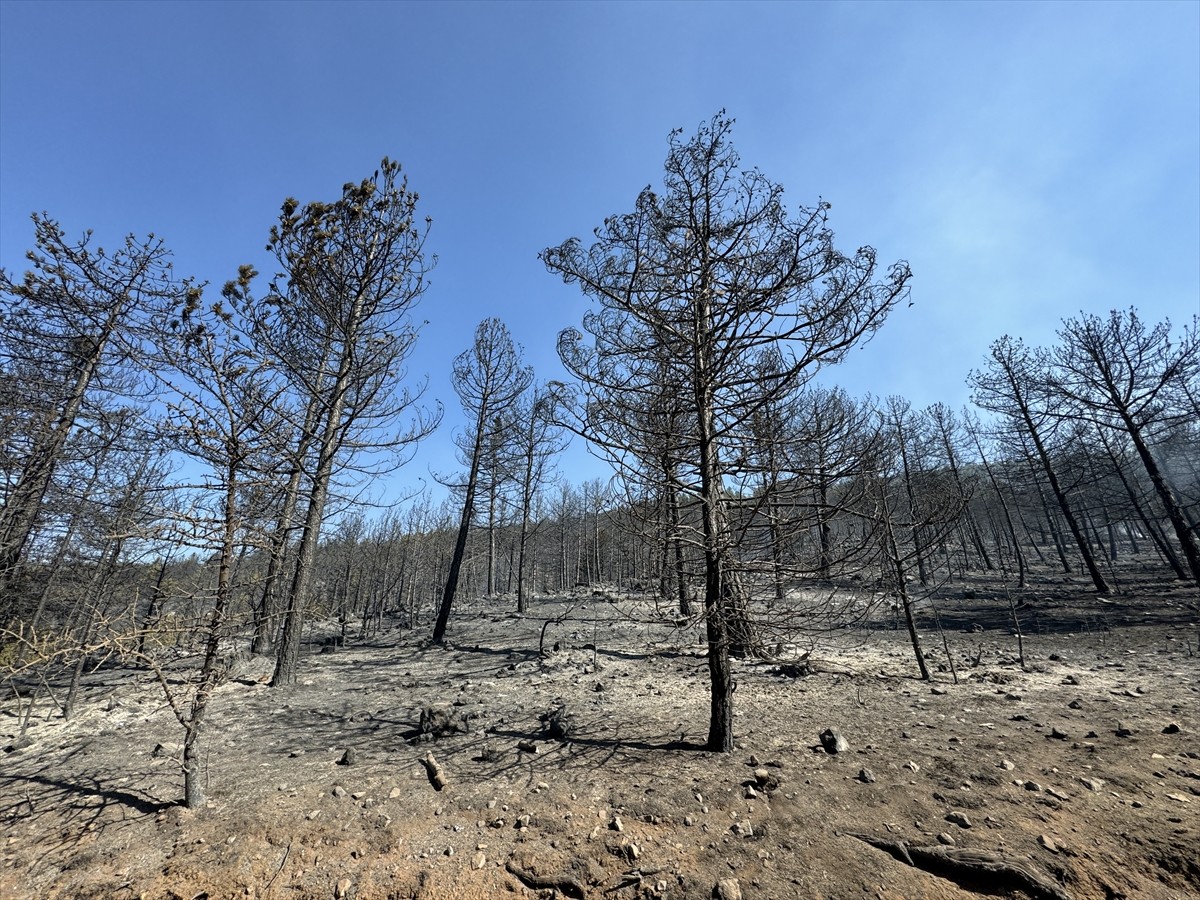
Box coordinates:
[0,572,1200,900]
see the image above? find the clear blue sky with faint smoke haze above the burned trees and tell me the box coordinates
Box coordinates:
[0,0,1200,504]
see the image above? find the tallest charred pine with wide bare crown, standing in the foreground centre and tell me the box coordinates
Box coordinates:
[541,113,910,751]
